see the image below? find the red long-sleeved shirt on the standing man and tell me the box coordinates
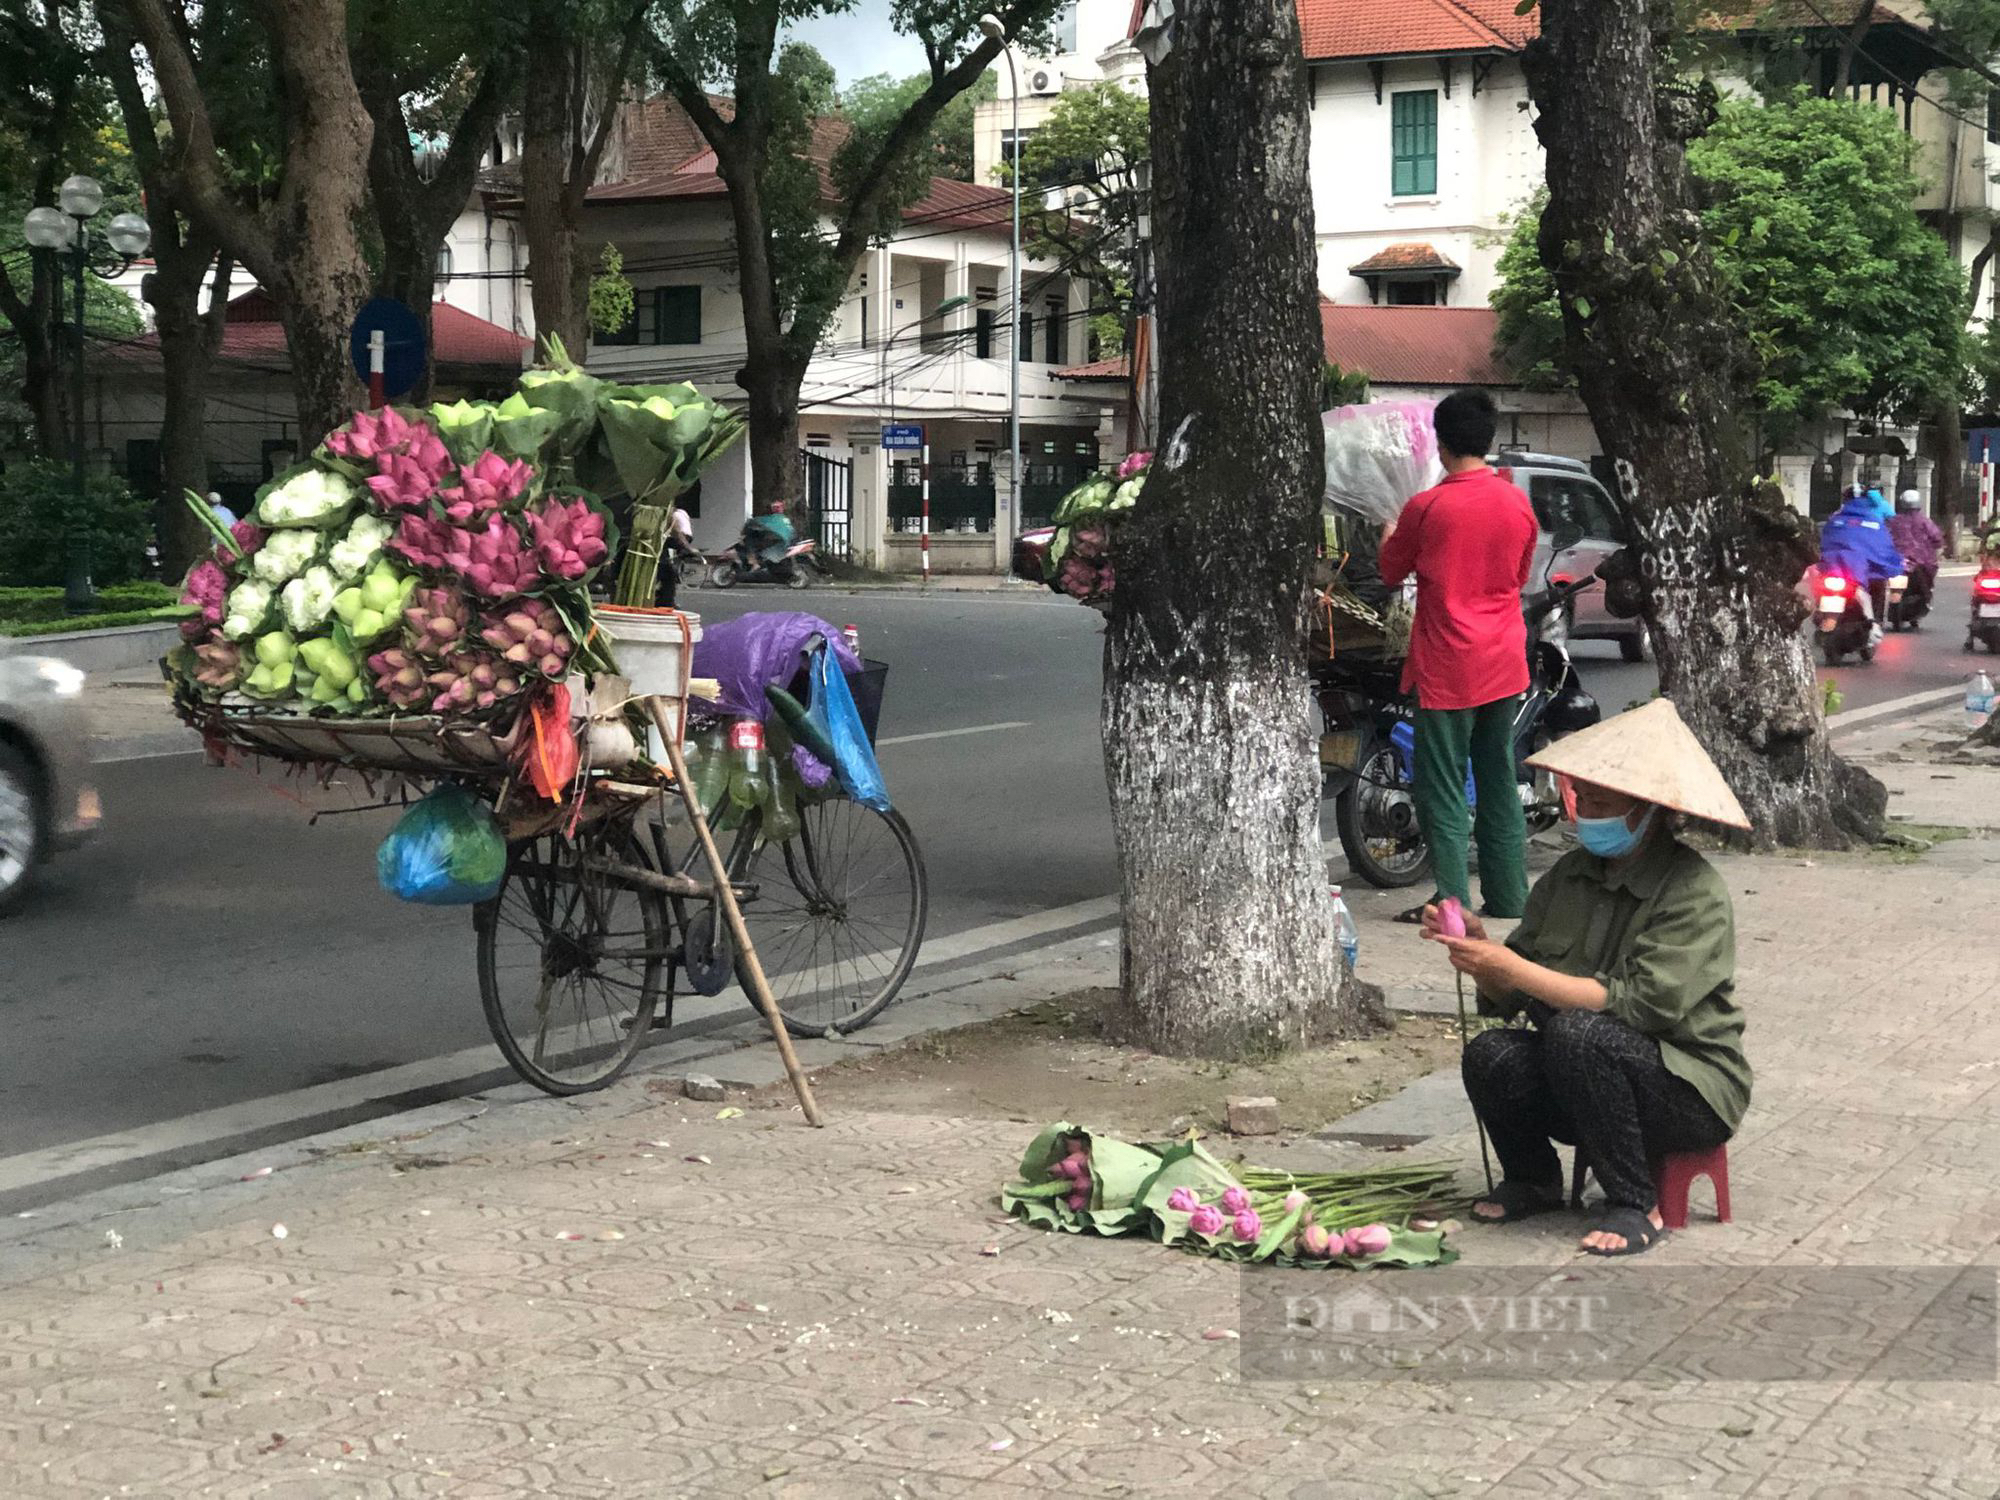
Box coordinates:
[1380,468,1536,708]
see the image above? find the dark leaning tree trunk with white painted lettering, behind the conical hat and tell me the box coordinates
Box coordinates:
[1524,0,1886,848]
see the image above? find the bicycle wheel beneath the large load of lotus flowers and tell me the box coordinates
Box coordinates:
[472,824,668,1094]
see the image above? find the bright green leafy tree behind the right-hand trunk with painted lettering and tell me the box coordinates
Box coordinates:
[1492,96,1966,434]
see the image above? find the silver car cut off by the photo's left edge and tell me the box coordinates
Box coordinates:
[0,656,102,916]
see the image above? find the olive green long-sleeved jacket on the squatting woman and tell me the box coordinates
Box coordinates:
[1480,836,1750,1130]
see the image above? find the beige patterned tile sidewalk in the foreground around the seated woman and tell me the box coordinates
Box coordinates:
[0,842,2000,1500]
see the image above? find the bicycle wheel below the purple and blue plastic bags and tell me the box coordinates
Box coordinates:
[730,798,930,1036]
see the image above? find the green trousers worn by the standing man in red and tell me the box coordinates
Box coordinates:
[1412,698,1528,916]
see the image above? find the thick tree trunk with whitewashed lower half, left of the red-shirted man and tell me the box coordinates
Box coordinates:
[1104,0,1372,1056]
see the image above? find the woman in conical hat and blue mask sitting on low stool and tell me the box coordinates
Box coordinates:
[1424,698,1750,1256]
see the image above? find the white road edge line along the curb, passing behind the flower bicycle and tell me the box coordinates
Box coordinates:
[0,896,1118,1192]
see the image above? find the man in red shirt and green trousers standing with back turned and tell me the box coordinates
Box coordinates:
[1380,390,1536,916]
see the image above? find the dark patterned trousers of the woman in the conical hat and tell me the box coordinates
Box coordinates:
[1460,1010,1730,1212]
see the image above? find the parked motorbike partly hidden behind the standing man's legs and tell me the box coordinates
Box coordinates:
[1314,538,1600,890]
